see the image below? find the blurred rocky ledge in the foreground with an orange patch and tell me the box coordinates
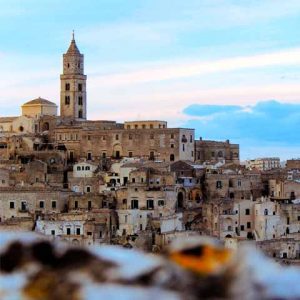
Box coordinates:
[0,232,300,300]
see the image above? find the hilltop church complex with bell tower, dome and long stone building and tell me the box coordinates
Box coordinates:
[0,34,195,163]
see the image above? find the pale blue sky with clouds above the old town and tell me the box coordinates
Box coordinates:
[0,0,300,160]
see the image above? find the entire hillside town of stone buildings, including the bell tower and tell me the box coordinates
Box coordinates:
[0,36,300,264]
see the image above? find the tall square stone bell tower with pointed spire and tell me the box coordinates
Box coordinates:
[60,32,86,121]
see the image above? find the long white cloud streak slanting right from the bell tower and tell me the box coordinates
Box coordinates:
[90,48,300,86]
